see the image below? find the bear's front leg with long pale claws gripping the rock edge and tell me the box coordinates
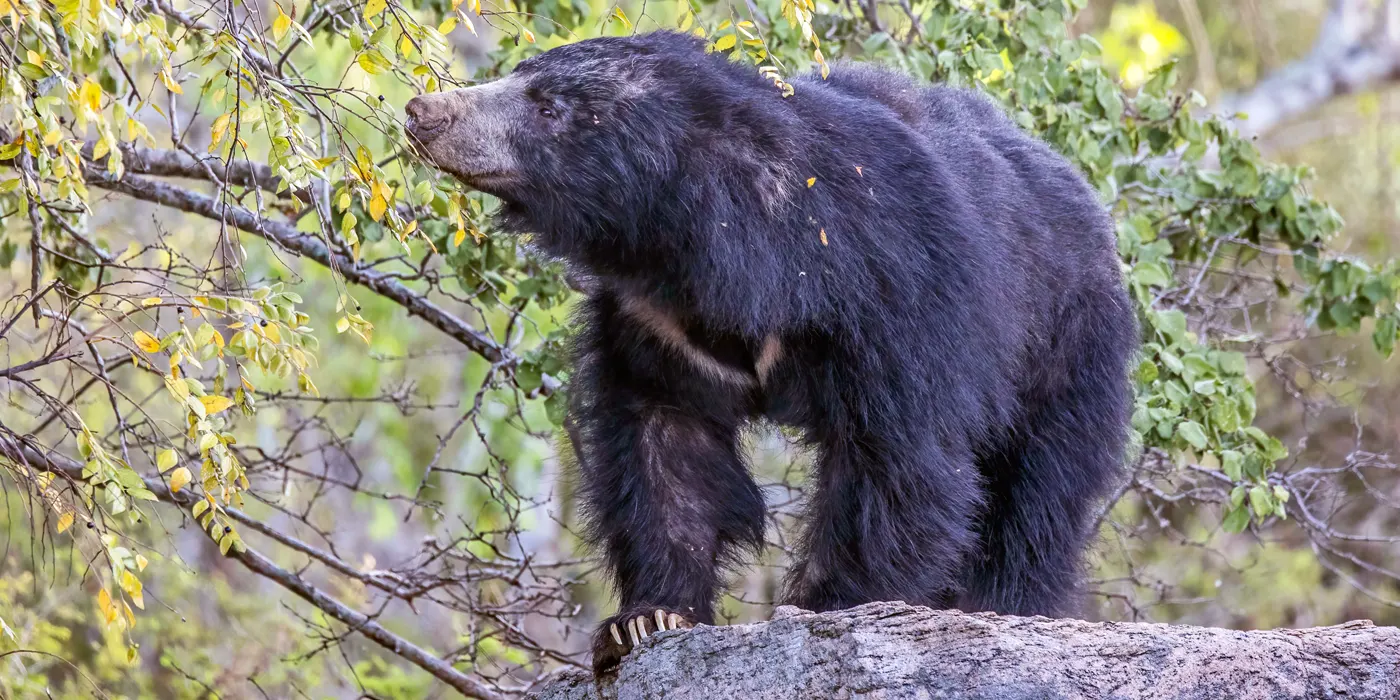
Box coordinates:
[575,392,763,672]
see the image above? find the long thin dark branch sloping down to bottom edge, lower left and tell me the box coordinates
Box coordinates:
[0,434,504,700]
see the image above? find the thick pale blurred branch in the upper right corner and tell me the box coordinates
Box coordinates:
[1217,0,1400,136]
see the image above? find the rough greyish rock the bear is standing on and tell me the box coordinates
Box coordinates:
[535,603,1400,700]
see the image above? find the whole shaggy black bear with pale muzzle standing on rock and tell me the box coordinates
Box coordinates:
[406,32,1137,672]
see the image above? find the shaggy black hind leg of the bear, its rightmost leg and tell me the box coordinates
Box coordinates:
[958,305,1131,616]
